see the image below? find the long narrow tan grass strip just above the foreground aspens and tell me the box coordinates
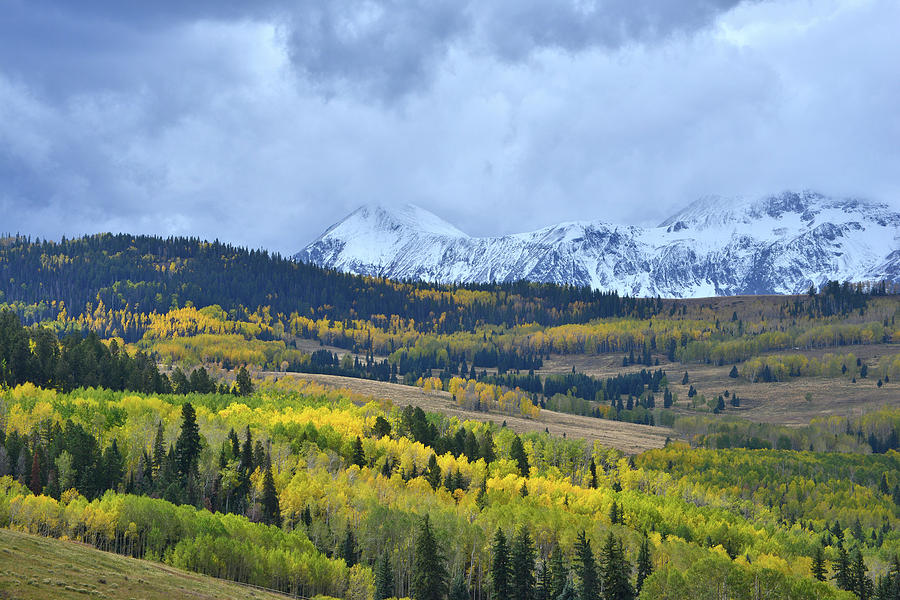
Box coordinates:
[264,372,677,454]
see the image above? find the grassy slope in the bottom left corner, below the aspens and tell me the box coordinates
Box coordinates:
[0,529,286,600]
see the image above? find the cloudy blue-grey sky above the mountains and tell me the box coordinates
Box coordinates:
[0,0,900,254]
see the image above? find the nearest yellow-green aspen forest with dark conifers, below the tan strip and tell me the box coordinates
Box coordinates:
[0,380,900,600]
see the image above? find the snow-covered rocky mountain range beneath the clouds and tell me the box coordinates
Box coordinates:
[294,192,900,297]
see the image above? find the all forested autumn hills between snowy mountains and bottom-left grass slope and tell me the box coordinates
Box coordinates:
[0,235,900,600]
